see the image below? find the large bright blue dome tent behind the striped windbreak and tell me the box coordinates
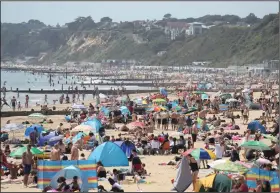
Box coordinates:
[88,142,129,167]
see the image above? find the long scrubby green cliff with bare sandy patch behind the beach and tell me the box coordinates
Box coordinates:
[1,14,279,66]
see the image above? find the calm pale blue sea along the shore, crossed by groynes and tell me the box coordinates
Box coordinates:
[1,70,154,108]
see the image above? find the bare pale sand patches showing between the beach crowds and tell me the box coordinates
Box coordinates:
[1,91,271,192]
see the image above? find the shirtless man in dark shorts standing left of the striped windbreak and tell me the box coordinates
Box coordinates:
[22,145,33,188]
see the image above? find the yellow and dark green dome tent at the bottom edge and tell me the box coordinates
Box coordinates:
[194,174,232,192]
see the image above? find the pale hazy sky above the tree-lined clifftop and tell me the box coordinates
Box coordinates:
[1,1,279,25]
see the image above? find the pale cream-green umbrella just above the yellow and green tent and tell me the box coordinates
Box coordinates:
[212,161,249,173]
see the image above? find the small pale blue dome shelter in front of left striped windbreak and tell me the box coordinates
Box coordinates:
[50,165,88,192]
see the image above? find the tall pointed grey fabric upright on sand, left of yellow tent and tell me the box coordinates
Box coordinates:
[173,157,192,192]
